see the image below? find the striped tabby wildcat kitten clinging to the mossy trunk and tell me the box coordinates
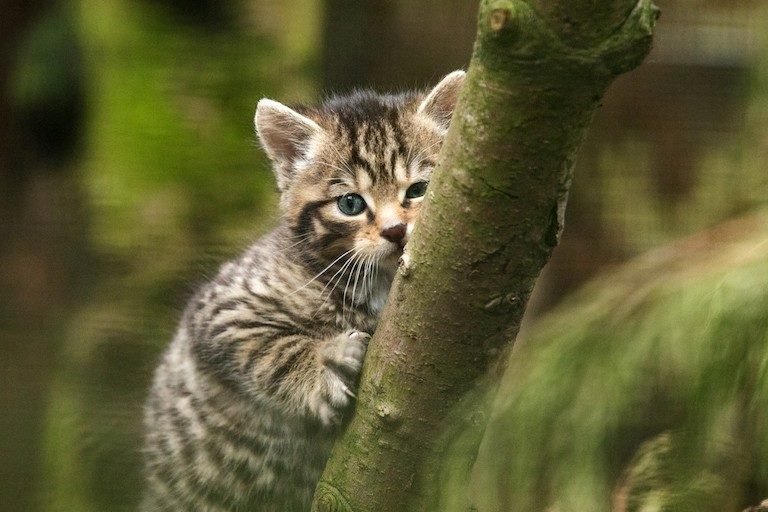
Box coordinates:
[143,71,464,512]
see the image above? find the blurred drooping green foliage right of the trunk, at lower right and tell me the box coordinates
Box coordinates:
[441,211,768,512]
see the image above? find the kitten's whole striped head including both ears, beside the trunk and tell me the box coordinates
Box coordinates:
[255,71,464,274]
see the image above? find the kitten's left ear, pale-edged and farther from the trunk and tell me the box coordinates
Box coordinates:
[253,98,322,190]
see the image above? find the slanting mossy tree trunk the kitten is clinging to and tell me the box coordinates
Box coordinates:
[313,0,658,512]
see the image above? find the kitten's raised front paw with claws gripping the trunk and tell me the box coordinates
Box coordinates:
[318,331,371,426]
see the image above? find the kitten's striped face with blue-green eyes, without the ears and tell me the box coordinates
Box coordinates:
[283,105,442,267]
